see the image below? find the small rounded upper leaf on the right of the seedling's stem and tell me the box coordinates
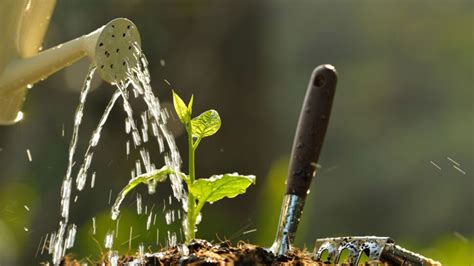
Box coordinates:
[191,110,221,138]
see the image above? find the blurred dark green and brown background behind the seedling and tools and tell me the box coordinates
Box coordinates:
[0,0,474,266]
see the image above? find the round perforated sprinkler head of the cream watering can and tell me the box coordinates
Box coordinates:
[94,18,141,84]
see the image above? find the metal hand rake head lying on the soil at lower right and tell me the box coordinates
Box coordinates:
[313,236,441,265]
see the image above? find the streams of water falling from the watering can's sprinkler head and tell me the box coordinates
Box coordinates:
[49,45,187,265]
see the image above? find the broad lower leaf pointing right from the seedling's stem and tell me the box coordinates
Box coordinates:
[189,173,255,205]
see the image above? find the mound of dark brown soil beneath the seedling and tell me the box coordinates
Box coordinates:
[62,240,319,265]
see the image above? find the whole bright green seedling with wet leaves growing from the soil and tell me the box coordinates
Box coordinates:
[112,91,255,243]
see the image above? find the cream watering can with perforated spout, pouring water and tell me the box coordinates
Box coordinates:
[0,0,140,125]
